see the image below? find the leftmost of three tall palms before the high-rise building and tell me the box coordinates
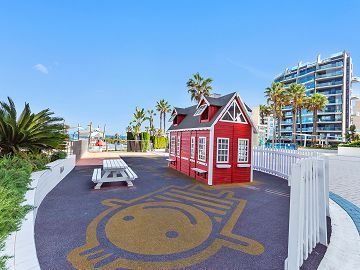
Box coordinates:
[265,82,286,146]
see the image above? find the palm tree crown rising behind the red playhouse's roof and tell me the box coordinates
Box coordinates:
[186,72,213,102]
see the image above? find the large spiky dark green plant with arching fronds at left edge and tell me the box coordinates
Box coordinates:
[0,97,67,155]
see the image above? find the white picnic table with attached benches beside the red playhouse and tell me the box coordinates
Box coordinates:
[92,158,138,189]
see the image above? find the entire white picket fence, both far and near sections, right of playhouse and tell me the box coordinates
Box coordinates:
[252,148,329,270]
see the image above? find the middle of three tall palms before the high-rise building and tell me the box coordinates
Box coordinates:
[287,83,306,143]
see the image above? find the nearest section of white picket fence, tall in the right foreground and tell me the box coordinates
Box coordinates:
[285,158,329,270]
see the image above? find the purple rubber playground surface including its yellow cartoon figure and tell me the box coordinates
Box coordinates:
[35,157,329,270]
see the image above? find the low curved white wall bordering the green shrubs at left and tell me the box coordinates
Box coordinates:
[2,155,75,270]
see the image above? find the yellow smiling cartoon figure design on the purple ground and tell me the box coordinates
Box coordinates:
[67,184,264,270]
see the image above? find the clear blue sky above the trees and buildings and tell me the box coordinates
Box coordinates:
[0,0,360,134]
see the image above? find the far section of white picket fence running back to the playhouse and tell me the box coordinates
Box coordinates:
[252,147,320,182]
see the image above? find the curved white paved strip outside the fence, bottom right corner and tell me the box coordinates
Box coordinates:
[318,200,360,270]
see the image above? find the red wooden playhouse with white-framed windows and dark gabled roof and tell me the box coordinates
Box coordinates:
[168,92,257,185]
